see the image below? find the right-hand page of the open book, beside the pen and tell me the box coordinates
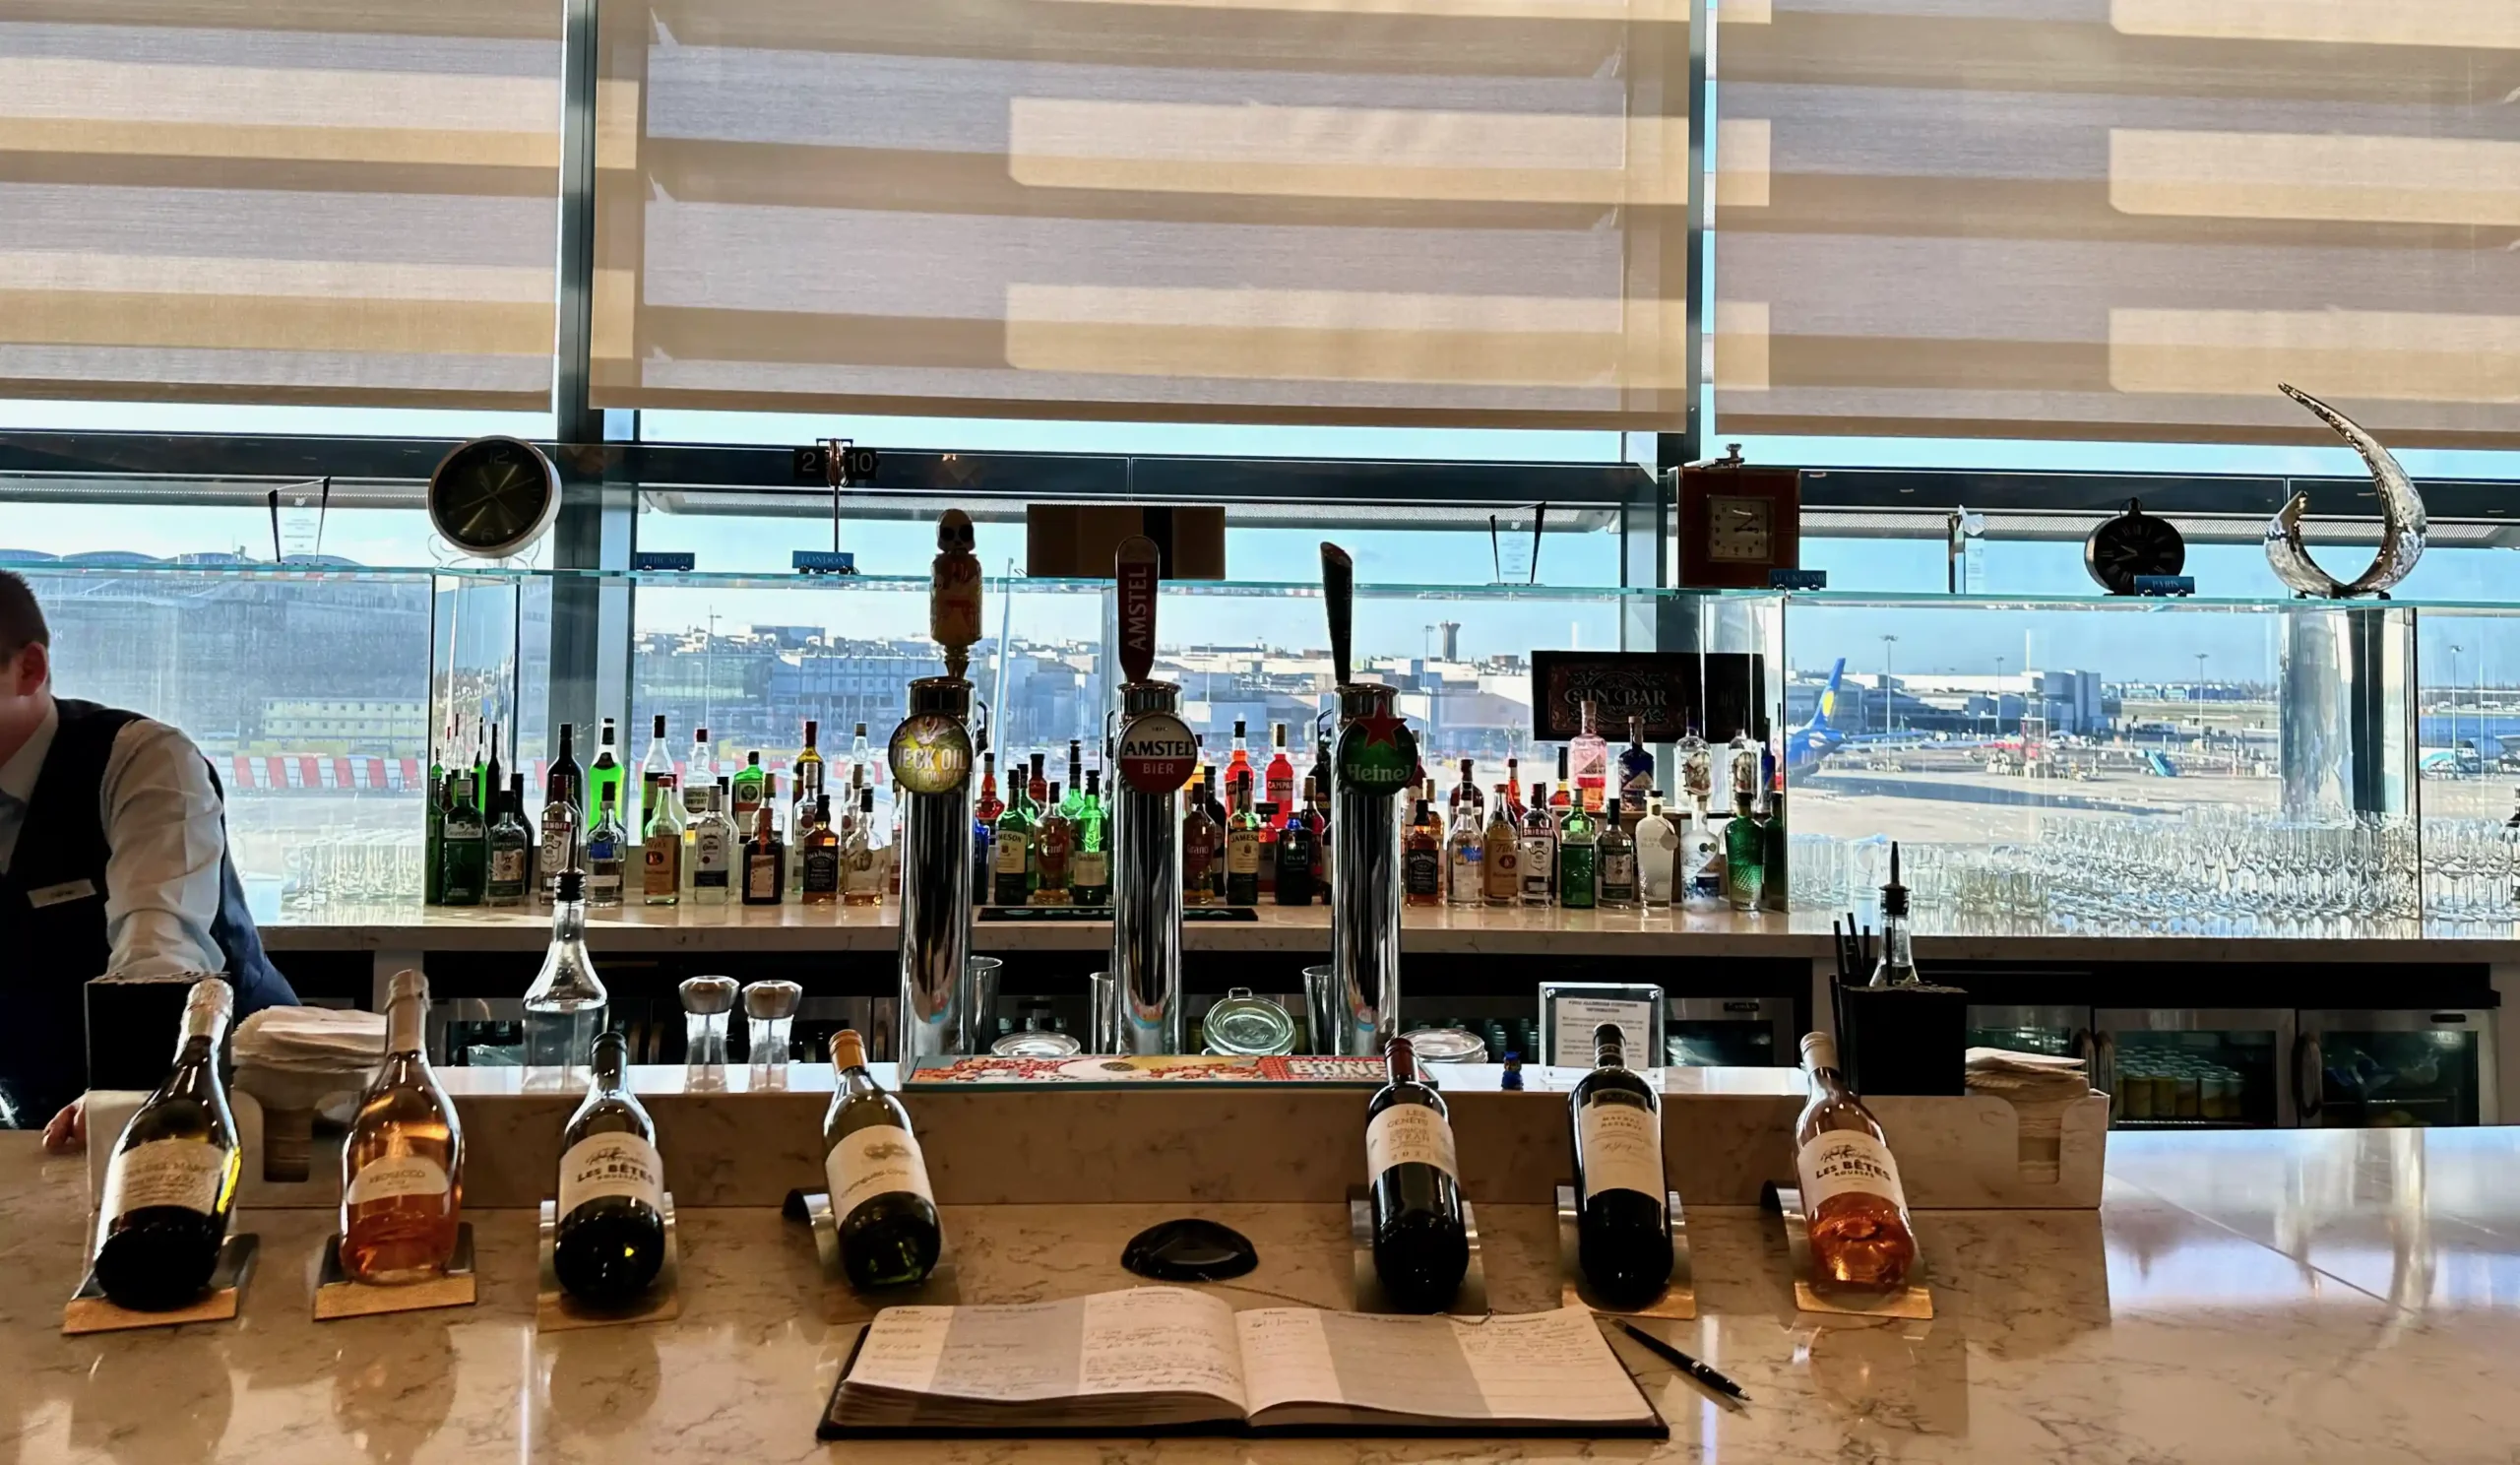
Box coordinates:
[1234,1308,1648,1422]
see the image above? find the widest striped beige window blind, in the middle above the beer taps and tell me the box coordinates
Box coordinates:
[593,0,1688,428]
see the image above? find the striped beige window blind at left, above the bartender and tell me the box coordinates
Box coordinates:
[0,0,559,411]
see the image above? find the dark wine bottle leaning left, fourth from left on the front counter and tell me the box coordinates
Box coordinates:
[822,1029,945,1286]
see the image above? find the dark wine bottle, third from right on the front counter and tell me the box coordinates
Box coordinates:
[1366,1039,1469,1311]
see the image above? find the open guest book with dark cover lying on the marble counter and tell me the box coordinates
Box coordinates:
[819,1286,1670,1439]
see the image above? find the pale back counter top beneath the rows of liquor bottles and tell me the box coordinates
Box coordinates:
[262,903,2520,961]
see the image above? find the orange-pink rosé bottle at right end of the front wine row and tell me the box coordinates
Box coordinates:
[1795,1034,1916,1291]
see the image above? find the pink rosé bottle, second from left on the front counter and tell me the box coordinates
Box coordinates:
[341,971,464,1286]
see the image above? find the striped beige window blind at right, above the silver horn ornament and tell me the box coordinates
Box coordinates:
[1714,0,2520,446]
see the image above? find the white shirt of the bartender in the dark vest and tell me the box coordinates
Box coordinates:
[0,709,226,976]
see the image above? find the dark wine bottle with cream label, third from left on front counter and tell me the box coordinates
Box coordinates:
[552,1031,665,1306]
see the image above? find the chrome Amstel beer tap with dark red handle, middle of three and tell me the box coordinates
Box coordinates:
[1094,535,1200,1056]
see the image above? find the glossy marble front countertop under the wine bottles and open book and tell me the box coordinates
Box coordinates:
[0,1129,2520,1465]
